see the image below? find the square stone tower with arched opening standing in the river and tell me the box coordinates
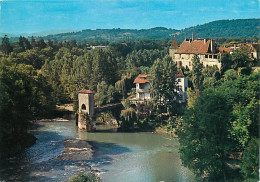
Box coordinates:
[78,90,96,131]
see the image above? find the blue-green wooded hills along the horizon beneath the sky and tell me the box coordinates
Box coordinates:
[10,19,260,42]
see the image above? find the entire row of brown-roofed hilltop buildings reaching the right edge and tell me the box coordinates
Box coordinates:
[169,35,260,70]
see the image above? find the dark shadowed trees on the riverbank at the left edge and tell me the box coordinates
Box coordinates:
[0,58,55,143]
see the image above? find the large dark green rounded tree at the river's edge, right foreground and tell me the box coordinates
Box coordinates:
[177,90,232,180]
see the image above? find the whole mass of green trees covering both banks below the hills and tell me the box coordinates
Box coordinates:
[0,36,260,181]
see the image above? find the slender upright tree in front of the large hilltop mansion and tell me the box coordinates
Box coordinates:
[191,55,204,95]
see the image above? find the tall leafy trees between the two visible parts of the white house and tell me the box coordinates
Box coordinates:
[149,56,177,113]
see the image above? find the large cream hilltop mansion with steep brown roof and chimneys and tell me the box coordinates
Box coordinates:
[169,38,221,69]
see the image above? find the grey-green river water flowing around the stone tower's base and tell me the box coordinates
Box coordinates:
[0,120,194,182]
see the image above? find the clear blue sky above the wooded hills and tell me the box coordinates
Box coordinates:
[0,0,260,34]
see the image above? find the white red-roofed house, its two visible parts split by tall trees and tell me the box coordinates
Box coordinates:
[134,69,188,103]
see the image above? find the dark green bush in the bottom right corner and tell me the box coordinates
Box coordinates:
[241,138,259,181]
